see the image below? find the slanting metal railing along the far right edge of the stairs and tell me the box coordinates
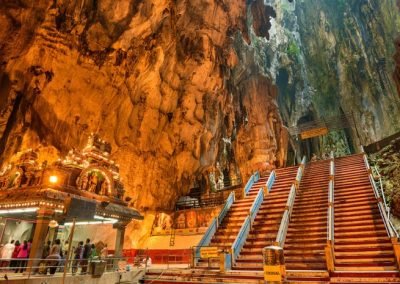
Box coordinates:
[361,147,400,240]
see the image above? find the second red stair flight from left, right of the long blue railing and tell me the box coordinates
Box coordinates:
[233,167,298,270]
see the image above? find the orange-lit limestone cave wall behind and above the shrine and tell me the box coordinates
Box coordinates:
[0,0,287,211]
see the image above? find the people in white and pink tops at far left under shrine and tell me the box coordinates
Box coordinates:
[0,240,32,273]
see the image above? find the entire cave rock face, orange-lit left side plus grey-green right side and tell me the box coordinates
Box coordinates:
[0,0,400,215]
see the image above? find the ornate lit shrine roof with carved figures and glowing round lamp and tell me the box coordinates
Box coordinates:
[0,134,143,223]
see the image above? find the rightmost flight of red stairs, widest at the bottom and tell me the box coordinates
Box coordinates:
[334,155,400,283]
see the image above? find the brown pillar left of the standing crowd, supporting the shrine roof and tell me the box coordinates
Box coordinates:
[27,208,54,273]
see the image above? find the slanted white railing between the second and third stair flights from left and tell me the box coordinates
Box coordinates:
[275,156,306,247]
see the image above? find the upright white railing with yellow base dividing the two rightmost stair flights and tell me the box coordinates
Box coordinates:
[325,152,335,271]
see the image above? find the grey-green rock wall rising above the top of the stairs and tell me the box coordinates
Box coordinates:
[265,0,400,153]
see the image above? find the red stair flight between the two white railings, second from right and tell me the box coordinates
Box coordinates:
[284,160,330,271]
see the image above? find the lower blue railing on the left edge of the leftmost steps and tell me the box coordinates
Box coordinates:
[193,191,235,266]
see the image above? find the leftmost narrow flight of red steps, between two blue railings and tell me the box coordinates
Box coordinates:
[198,172,268,267]
